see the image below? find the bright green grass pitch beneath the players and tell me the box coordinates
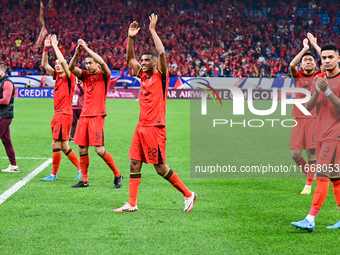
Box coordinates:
[0,99,340,254]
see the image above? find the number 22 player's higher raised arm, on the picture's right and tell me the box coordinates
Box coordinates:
[149,13,167,75]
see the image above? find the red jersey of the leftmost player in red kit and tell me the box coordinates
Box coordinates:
[53,72,76,115]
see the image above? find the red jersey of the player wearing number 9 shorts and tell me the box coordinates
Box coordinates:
[80,70,111,117]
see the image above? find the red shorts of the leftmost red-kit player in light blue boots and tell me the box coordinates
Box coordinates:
[51,113,73,141]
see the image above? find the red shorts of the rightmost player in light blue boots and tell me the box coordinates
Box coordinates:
[316,140,340,178]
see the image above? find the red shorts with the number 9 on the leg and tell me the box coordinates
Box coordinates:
[73,116,104,146]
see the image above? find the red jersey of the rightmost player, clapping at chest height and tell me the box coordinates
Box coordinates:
[312,73,340,141]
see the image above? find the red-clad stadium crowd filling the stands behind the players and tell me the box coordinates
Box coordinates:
[0,0,340,77]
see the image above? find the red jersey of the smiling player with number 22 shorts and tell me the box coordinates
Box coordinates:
[137,68,169,126]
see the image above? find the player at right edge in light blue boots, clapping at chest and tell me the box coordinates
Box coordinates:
[291,44,340,232]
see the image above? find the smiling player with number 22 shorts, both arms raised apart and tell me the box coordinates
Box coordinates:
[114,14,197,212]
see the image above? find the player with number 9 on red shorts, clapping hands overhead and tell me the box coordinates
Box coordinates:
[70,39,123,188]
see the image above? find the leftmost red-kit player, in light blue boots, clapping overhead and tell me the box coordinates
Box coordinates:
[40,35,81,181]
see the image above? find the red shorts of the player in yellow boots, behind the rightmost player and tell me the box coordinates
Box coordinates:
[289,118,316,150]
